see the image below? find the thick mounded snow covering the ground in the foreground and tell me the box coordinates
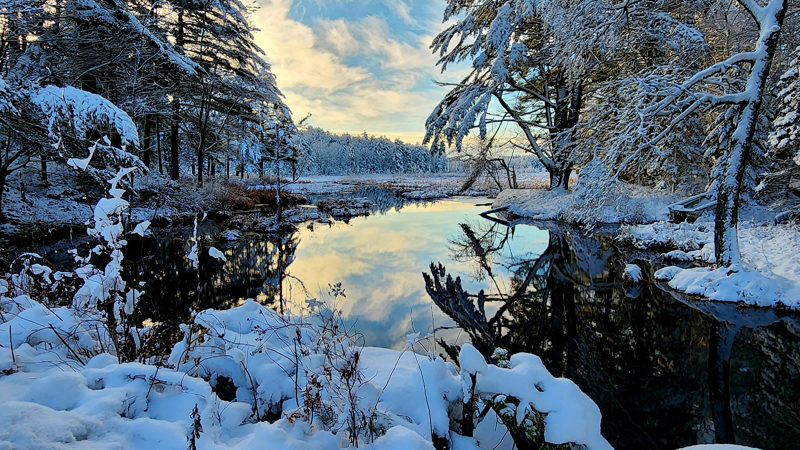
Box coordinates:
[0,296,610,449]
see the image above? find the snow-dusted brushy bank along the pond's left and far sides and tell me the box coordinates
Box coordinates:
[0,166,520,258]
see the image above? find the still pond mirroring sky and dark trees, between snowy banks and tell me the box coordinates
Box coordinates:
[120,198,800,449]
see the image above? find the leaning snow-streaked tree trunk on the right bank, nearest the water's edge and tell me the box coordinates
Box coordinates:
[714,0,788,267]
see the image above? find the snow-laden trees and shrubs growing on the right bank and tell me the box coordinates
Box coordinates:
[425,0,800,304]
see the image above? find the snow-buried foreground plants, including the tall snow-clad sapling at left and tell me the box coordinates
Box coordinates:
[0,169,610,449]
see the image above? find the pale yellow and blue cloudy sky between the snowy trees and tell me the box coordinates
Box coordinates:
[252,0,463,143]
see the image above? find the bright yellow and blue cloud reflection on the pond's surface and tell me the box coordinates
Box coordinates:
[282,198,547,348]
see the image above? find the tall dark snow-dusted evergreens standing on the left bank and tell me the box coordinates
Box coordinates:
[0,0,295,220]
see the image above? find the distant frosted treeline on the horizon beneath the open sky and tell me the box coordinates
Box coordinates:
[298,127,448,175]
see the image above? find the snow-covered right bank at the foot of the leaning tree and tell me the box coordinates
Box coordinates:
[492,184,800,310]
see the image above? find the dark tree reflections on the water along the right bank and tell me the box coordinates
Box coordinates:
[424,222,800,448]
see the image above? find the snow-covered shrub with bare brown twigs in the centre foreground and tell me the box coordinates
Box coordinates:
[169,283,386,446]
